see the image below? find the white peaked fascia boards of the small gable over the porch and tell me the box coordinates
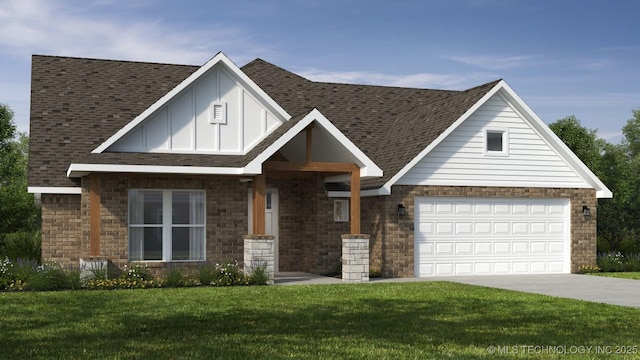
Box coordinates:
[245,108,382,177]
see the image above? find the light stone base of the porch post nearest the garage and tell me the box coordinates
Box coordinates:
[342,234,369,282]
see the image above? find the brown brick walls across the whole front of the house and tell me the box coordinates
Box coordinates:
[42,174,597,277]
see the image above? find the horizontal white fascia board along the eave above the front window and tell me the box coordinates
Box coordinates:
[67,164,243,178]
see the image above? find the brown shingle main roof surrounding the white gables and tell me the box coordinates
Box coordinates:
[29,56,496,188]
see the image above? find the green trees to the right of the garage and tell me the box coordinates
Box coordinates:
[549,109,640,253]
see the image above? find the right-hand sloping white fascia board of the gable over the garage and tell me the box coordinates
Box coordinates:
[500,81,613,199]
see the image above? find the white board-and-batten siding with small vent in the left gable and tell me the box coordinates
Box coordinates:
[109,65,285,154]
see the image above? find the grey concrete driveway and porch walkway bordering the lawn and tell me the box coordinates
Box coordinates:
[275,273,640,308]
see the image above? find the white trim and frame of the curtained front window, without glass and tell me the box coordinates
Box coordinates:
[127,188,207,263]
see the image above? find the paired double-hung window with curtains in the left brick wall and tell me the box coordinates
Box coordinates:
[129,190,205,261]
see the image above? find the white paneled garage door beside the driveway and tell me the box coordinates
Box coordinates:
[415,197,570,277]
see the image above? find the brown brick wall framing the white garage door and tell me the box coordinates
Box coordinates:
[362,185,597,277]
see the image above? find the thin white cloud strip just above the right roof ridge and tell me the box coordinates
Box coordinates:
[297,70,497,89]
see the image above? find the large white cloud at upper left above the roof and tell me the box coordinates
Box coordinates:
[0,0,268,64]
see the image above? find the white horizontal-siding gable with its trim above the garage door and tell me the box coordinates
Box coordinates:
[383,81,611,197]
